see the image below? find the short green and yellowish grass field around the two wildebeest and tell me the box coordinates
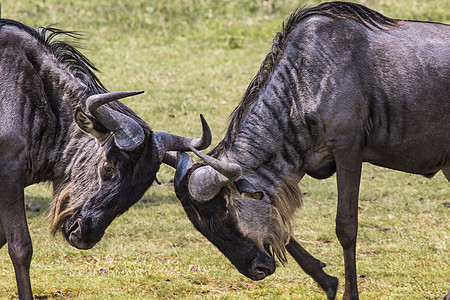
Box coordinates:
[0,0,450,299]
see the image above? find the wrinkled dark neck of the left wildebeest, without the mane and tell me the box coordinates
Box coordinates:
[1,35,92,185]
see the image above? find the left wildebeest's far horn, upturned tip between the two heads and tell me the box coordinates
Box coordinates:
[153,114,212,157]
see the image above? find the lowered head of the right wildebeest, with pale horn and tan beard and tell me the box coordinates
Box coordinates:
[174,149,299,280]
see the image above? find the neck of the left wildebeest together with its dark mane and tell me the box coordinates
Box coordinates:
[0,19,104,185]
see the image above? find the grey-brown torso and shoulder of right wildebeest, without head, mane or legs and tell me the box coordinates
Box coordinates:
[227,16,450,180]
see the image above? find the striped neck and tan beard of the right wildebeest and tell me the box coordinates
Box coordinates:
[207,89,307,261]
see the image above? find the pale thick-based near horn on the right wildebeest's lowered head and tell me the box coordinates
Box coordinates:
[188,147,242,202]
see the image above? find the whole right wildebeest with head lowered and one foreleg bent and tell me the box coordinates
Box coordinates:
[171,2,450,299]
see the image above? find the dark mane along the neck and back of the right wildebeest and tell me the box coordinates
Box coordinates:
[210,1,399,156]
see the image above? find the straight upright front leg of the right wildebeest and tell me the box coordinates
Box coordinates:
[335,151,362,300]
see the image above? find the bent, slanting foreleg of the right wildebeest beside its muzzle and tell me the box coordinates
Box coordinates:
[286,237,339,300]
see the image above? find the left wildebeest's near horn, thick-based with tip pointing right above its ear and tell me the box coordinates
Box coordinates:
[86,91,145,150]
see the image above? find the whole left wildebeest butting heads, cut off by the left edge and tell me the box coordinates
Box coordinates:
[0,19,211,299]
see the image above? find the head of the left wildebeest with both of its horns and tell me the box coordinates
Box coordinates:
[52,92,211,249]
